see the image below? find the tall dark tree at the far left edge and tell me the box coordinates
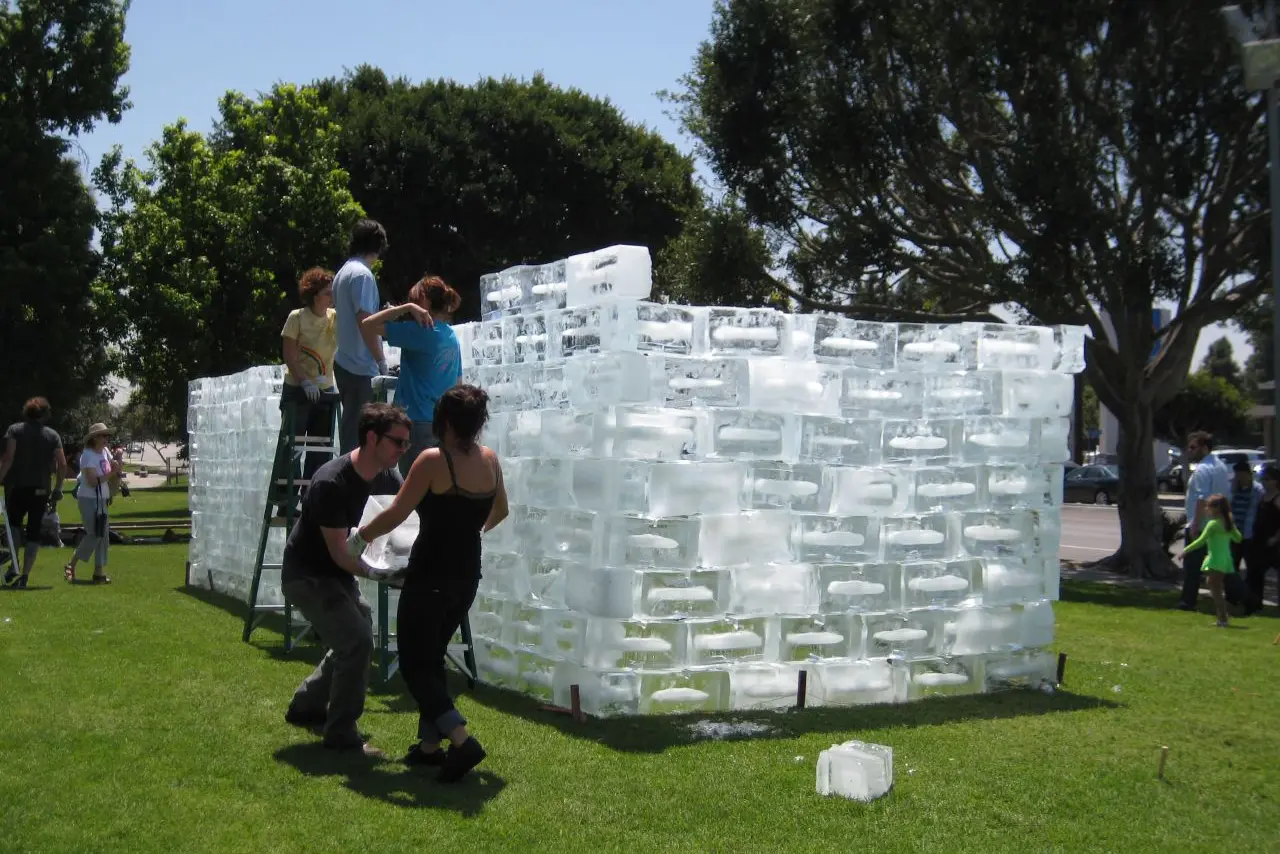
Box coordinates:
[0,0,129,430]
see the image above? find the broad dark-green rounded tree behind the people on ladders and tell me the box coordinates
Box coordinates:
[317,65,701,318]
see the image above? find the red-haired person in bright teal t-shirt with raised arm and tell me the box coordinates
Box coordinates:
[361,275,462,476]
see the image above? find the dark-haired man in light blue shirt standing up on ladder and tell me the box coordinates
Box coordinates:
[333,219,387,453]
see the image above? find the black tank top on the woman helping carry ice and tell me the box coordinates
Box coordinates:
[408,448,500,580]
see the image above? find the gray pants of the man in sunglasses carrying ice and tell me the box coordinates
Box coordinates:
[282,577,374,748]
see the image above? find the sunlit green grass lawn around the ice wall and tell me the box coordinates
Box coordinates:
[0,545,1280,854]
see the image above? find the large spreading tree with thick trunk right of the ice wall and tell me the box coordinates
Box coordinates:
[677,0,1267,575]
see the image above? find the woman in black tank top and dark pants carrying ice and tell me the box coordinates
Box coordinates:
[360,385,507,782]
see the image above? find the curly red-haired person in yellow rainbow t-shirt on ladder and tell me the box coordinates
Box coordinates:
[280,266,338,515]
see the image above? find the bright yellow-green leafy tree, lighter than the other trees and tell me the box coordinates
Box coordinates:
[95,85,361,428]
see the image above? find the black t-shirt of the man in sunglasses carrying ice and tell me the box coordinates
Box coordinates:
[280,453,403,581]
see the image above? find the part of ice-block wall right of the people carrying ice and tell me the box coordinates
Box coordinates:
[457,247,1084,714]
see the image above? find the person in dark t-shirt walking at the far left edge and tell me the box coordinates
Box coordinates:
[0,397,69,588]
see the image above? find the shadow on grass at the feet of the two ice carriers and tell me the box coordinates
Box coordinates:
[275,743,507,818]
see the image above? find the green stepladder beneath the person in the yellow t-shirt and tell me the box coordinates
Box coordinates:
[242,402,339,652]
